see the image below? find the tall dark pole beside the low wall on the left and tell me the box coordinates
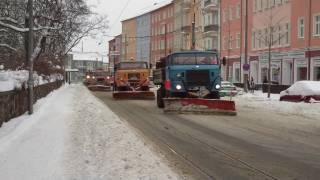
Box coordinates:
[27,0,34,114]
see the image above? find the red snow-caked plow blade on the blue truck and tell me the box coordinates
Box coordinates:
[164,98,237,116]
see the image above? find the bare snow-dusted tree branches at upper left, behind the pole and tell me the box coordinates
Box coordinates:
[0,0,108,73]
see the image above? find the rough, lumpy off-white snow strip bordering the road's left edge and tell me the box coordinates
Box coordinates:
[66,86,178,180]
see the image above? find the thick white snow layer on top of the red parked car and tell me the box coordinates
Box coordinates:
[280,81,320,96]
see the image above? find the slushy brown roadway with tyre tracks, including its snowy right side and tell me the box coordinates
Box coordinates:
[94,92,320,180]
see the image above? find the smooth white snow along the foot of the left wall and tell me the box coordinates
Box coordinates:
[0,86,74,180]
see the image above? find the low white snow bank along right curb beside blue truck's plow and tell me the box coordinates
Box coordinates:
[234,91,320,119]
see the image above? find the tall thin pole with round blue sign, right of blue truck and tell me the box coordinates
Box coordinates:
[245,0,249,92]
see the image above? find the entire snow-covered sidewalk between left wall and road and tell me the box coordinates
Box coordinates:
[0,85,179,180]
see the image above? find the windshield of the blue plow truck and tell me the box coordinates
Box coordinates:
[171,54,219,65]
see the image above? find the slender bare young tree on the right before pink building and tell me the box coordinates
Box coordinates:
[253,7,290,98]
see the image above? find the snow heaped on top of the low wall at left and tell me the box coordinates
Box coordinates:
[0,70,63,92]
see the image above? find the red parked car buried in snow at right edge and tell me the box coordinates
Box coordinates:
[280,81,320,102]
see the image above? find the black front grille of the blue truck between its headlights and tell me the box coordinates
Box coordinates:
[186,70,210,86]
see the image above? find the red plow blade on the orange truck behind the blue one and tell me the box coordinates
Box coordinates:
[112,91,155,100]
